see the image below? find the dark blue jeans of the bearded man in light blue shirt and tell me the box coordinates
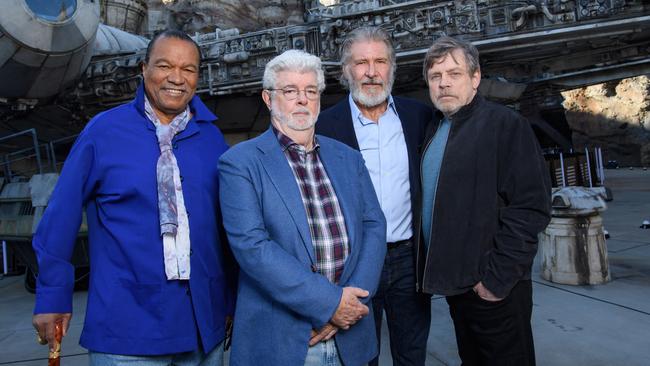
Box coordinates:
[370,241,431,366]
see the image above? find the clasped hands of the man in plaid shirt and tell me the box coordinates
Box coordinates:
[309,287,370,347]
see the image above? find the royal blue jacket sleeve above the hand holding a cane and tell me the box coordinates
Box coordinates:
[32,132,97,314]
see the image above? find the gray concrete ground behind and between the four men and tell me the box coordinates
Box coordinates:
[0,169,650,366]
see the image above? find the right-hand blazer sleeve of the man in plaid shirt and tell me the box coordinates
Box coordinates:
[336,154,386,303]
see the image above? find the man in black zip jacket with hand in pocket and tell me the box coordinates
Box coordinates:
[417,37,550,365]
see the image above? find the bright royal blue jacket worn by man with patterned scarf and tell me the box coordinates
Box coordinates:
[33,85,235,355]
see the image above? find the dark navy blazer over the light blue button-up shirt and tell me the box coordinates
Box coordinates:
[316,96,433,237]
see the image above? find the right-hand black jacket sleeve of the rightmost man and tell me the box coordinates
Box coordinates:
[482,117,551,297]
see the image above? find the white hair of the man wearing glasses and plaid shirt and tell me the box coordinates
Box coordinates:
[262,50,325,92]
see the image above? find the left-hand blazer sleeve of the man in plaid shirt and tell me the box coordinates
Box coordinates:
[219,150,343,329]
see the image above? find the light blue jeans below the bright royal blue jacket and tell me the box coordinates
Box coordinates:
[88,342,223,366]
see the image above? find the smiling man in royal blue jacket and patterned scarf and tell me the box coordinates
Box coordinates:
[33,31,236,365]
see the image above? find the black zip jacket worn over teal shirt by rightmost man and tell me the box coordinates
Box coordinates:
[416,94,551,297]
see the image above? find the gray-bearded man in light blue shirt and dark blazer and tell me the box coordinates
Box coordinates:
[316,27,431,366]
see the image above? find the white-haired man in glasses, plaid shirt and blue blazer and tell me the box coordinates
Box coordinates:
[219,50,386,366]
